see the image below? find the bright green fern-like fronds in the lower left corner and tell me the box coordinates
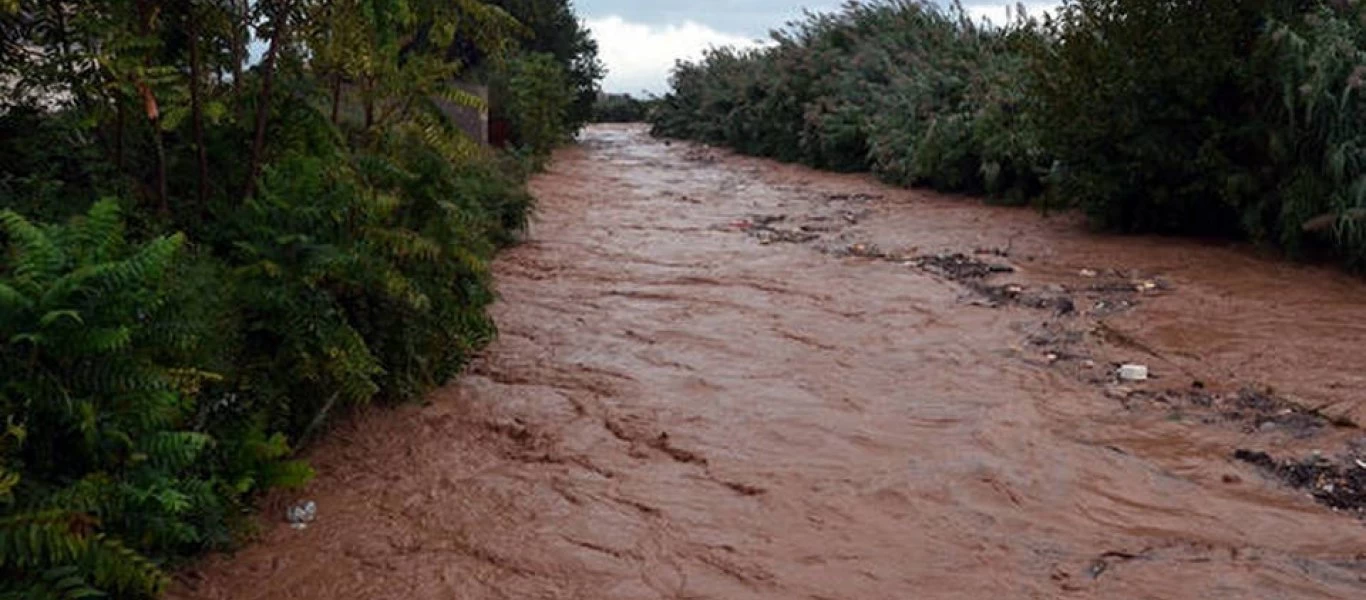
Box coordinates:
[0,201,221,597]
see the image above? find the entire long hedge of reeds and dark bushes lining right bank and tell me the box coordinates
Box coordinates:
[652,0,1366,265]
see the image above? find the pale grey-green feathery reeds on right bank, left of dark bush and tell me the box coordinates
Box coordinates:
[652,1,1049,201]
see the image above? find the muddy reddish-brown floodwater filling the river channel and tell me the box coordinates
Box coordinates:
[171,126,1366,600]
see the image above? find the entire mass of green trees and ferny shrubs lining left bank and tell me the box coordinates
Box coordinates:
[0,0,592,600]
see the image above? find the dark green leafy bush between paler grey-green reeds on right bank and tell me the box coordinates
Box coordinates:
[1033,0,1268,232]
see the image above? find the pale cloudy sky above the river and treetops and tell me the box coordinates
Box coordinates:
[574,0,1057,94]
